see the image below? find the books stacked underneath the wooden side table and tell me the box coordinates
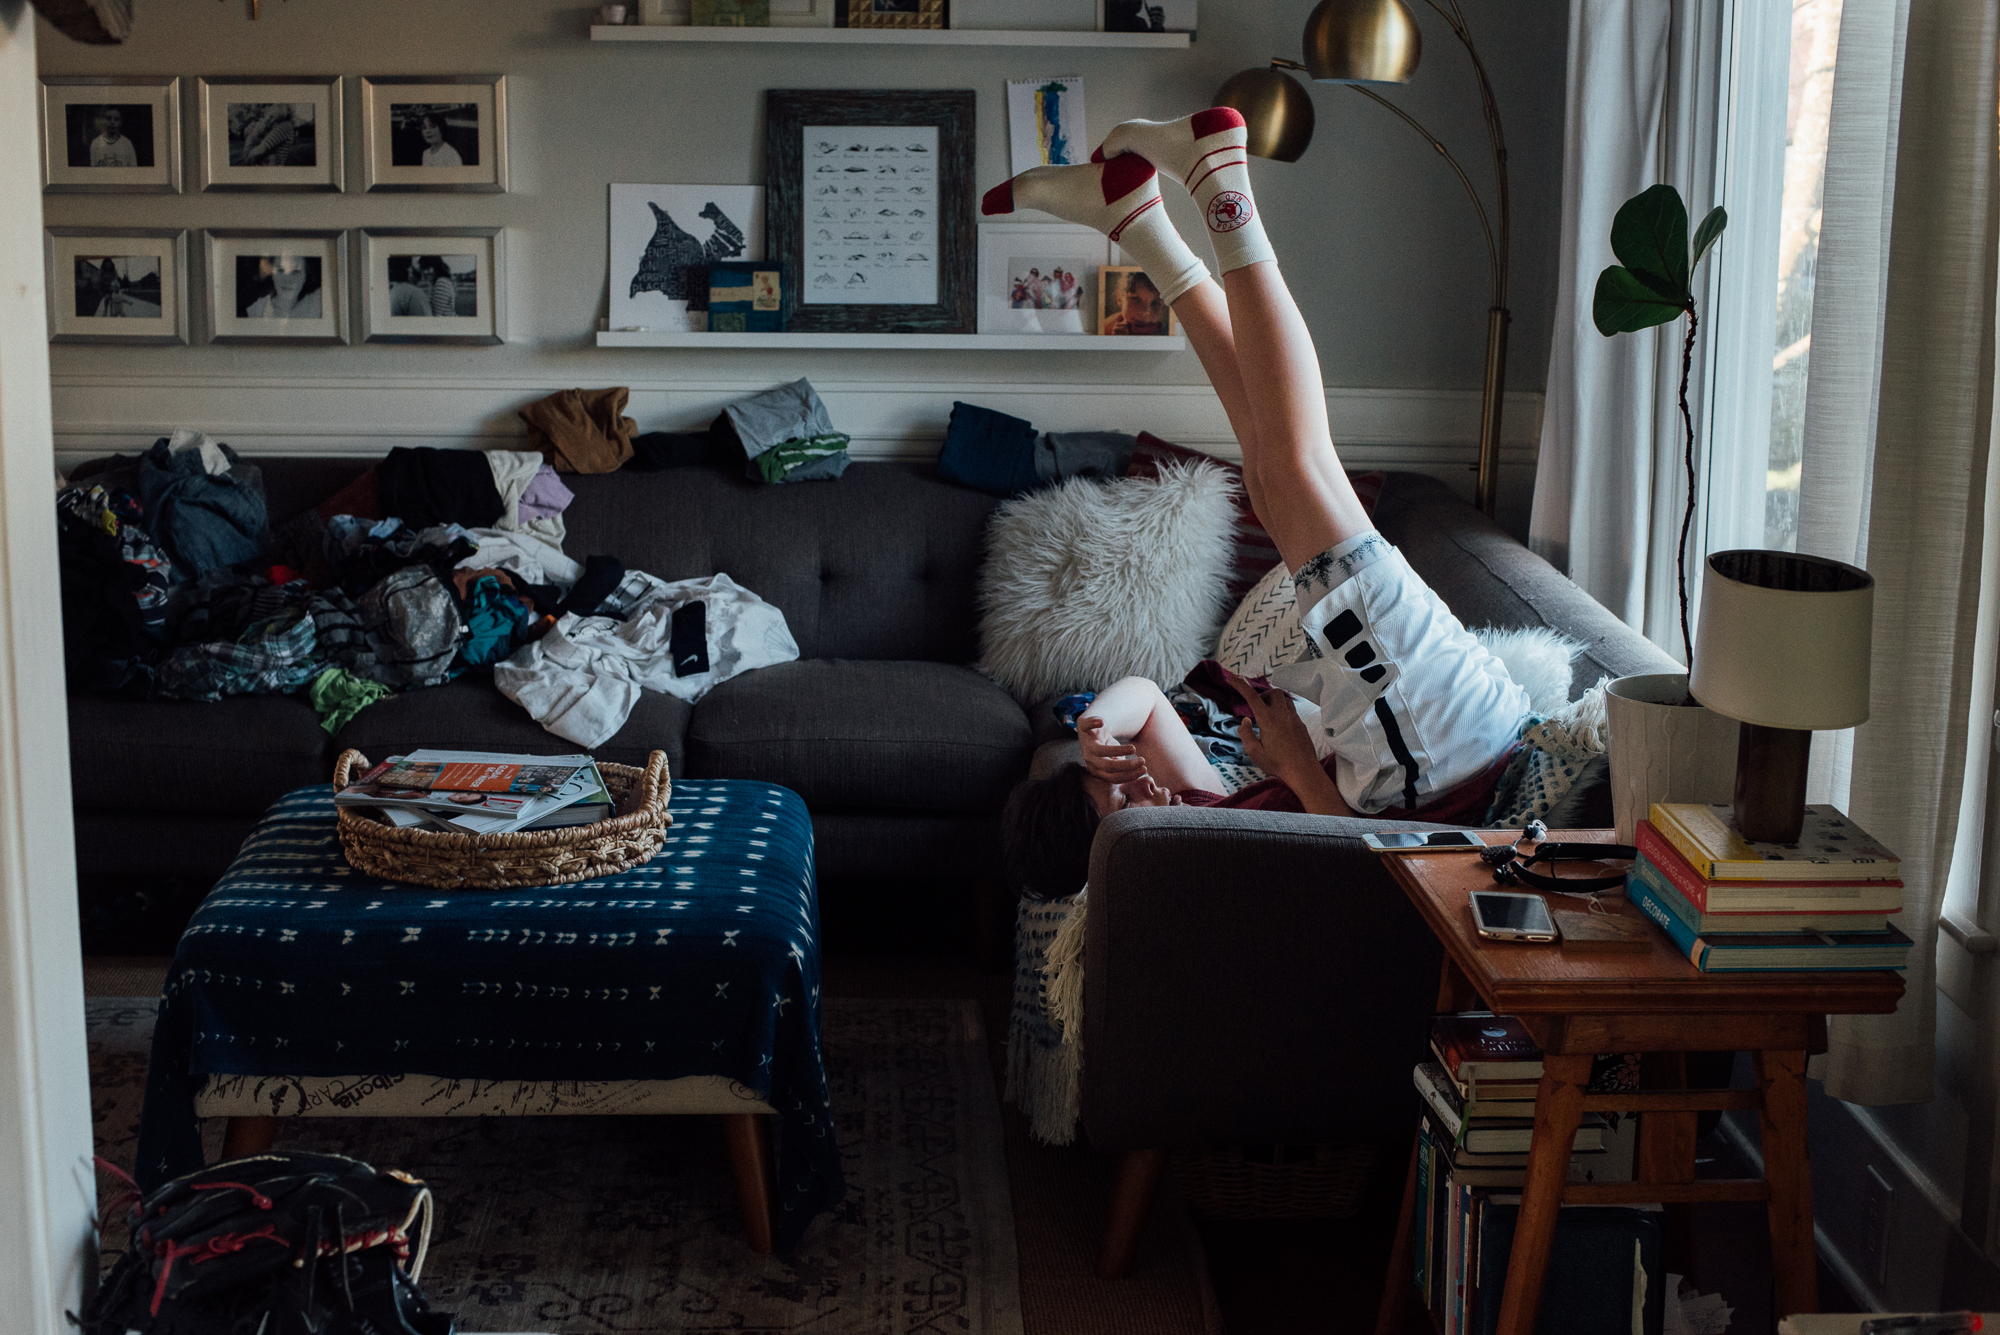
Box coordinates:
[1410,1011,1662,1335]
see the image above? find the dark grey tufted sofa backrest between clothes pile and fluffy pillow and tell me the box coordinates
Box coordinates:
[256,458,998,667]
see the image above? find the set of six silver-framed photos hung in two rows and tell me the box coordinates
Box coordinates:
[40,74,508,346]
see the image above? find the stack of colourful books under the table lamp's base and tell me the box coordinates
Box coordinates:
[1626,801,1910,973]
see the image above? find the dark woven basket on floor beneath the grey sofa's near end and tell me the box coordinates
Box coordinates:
[1168,1145,1376,1219]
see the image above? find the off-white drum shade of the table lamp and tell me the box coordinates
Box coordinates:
[1688,552,1874,729]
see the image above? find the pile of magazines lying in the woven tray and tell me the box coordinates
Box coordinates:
[334,751,618,833]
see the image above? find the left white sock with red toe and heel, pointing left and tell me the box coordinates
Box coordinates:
[980,154,1208,306]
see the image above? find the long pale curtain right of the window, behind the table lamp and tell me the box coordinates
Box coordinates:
[1798,0,2000,1103]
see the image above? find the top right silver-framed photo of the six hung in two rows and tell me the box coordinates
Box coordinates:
[362,74,506,194]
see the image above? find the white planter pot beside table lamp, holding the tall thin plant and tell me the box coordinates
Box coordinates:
[1604,671,1740,843]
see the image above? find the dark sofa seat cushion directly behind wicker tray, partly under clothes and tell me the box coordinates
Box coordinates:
[334,677,690,777]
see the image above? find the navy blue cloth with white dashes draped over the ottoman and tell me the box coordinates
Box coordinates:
[136,779,846,1253]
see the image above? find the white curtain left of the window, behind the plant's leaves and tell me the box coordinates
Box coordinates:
[1528,0,1672,626]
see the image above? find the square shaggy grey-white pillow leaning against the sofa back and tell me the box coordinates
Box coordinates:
[980,464,1236,701]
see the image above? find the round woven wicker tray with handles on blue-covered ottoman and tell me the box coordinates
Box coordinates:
[334,749,674,889]
